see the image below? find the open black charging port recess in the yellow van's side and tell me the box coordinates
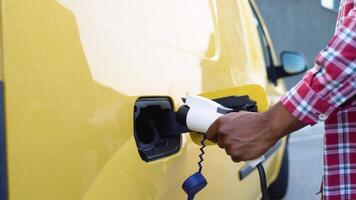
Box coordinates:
[134,97,180,162]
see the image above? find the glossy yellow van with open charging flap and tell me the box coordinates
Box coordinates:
[0,0,304,200]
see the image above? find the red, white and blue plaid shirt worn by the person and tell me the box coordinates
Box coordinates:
[281,0,356,200]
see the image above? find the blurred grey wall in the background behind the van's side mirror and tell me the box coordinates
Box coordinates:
[256,0,337,88]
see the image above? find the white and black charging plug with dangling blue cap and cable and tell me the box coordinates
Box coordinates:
[149,96,269,200]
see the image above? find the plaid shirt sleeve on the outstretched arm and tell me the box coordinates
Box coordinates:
[281,8,356,125]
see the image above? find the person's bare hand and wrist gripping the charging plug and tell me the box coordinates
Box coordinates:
[206,103,305,162]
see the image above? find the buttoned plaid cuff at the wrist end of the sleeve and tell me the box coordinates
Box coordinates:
[281,80,336,125]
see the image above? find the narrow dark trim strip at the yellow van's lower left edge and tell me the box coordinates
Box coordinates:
[0,81,7,200]
